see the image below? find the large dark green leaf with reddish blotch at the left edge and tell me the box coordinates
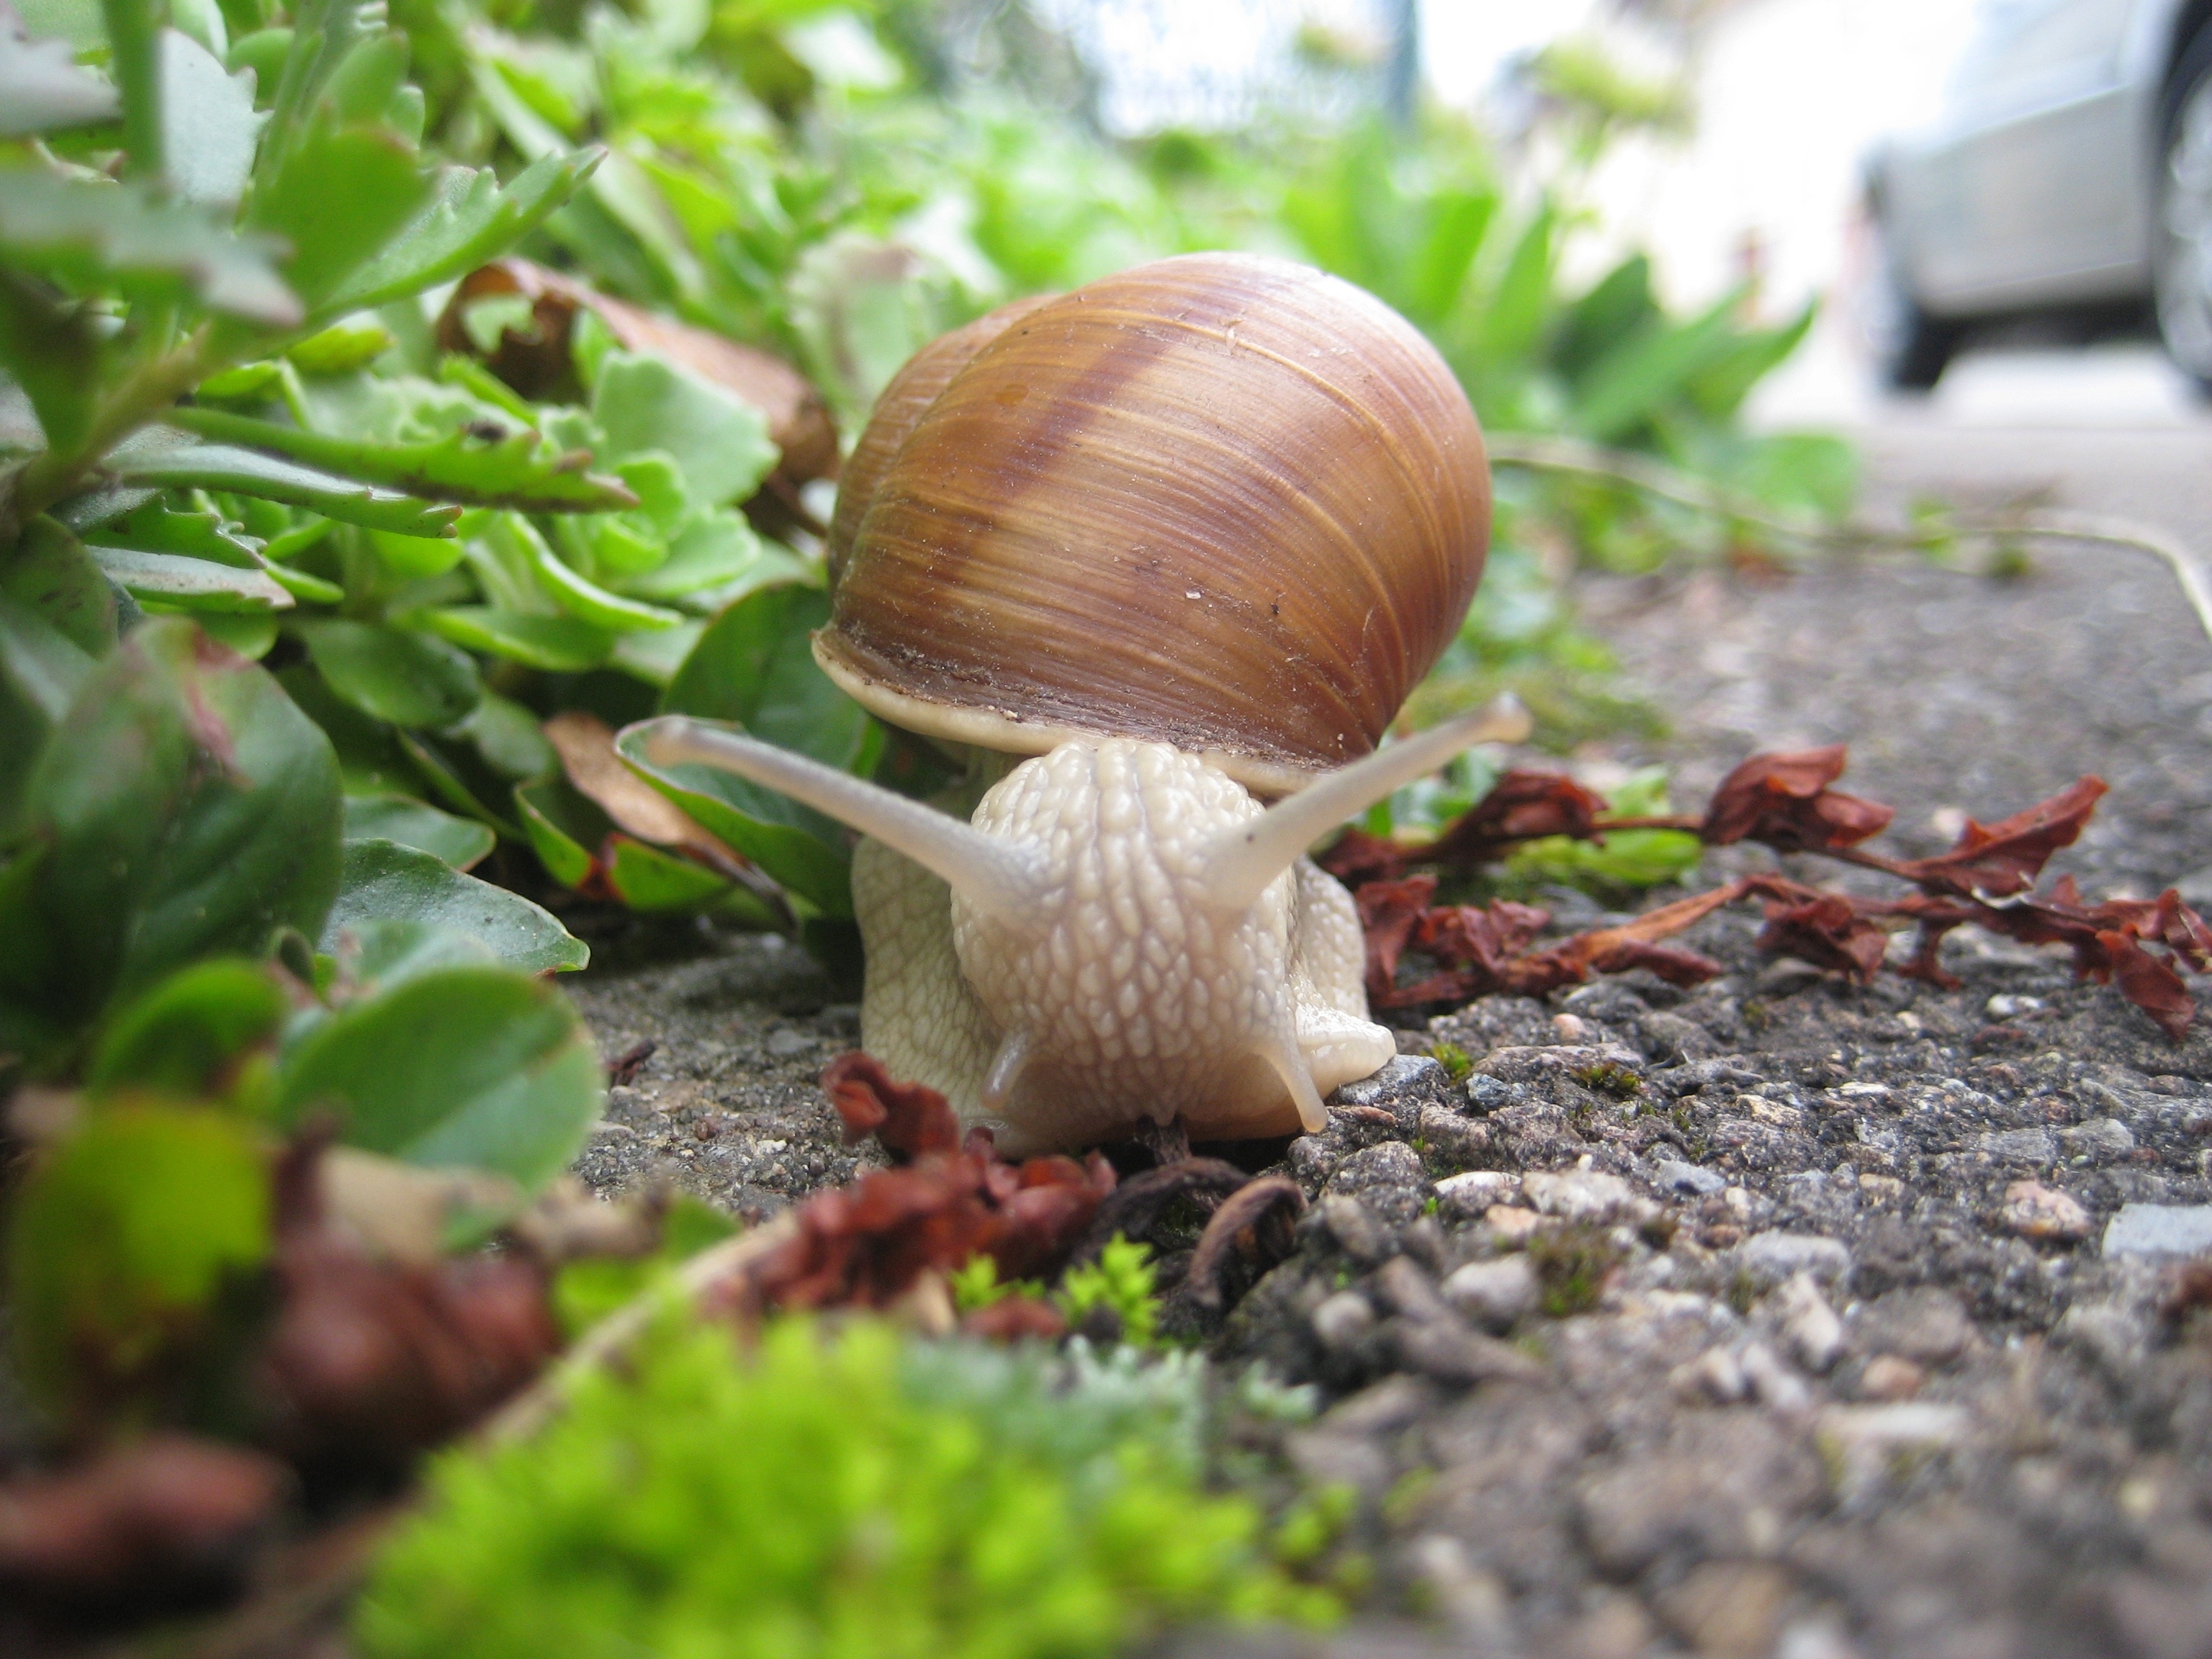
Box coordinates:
[0,617,338,1039]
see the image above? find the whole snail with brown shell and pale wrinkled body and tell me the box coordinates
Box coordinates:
[646,254,1527,1153]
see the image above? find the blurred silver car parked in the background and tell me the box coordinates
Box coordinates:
[1867,0,2212,392]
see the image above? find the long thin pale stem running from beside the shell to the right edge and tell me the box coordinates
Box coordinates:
[1486,433,2212,642]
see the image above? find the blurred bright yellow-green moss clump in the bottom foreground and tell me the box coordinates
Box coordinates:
[356,1318,1336,1659]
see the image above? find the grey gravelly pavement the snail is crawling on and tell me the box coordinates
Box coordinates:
[571,431,2212,1659]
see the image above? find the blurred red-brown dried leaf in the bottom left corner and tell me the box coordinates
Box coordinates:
[0,1434,289,1606]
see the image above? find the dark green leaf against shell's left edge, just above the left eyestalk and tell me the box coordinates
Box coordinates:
[662,584,867,770]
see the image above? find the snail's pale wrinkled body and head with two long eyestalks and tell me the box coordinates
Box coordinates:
[644,708,1527,1155]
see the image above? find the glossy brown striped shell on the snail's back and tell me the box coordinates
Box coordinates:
[814,254,1491,790]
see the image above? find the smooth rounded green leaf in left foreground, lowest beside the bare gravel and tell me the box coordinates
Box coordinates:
[281,966,606,1192]
